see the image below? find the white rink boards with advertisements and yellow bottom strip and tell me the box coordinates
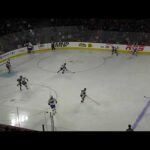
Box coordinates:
[0,42,150,64]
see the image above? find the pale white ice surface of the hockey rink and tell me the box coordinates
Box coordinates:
[0,50,150,131]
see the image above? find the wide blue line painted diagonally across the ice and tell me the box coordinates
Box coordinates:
[132,100,150,129]
